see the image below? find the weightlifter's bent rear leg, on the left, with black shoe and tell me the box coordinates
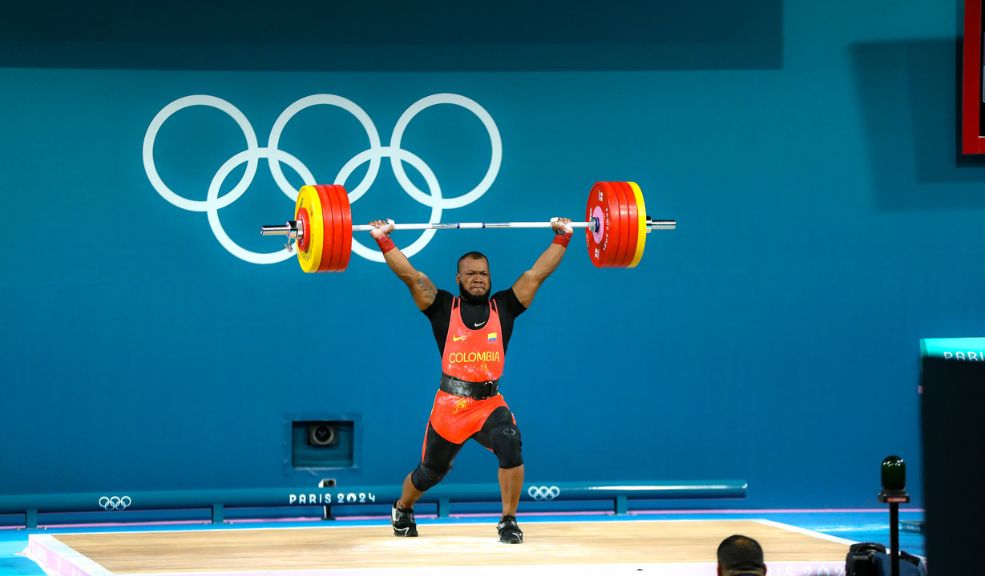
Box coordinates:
[391,422,462,536]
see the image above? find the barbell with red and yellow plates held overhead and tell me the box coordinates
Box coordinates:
[260,182,677,272]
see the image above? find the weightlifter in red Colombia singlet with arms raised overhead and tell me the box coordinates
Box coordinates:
[370,218,572,544]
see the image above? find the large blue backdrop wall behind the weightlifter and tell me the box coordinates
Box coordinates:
[0,0,985,507]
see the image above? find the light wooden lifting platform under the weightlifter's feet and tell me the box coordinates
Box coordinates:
[26,520,847,575]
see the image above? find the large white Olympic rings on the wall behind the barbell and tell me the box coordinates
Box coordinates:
[143,94,503,264]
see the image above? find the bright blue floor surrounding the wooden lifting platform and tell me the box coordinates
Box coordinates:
[0,510,925,576]
